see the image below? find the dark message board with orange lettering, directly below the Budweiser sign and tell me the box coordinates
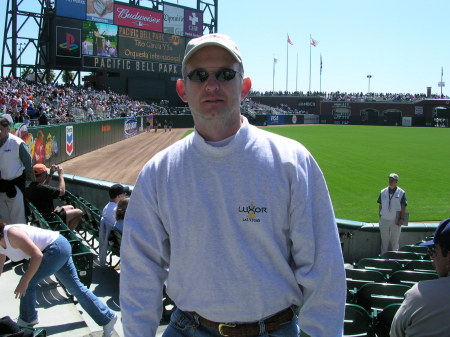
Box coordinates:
[119,27,185,63]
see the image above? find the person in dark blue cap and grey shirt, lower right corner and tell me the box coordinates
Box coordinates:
[390,219,450,337]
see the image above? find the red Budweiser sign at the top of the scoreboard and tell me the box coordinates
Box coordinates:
[114,3,164,32]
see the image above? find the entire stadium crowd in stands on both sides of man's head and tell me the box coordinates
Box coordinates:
[0,78,449,125]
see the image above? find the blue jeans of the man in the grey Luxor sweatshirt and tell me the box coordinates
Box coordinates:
[163,308,300,337]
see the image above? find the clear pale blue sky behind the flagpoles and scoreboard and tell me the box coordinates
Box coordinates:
[0,0,450,95]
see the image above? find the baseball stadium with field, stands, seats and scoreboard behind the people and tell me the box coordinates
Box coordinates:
[0,0,450,337]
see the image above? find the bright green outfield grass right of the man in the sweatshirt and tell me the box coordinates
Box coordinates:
[265,125,450,222]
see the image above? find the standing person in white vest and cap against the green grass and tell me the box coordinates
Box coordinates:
[377,173,408,254]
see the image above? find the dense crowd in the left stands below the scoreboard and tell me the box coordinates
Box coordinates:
[0,78,178,125]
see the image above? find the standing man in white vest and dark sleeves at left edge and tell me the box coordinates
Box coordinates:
[0,115,35,223]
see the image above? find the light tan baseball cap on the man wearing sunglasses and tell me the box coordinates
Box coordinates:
[181,33,242,74]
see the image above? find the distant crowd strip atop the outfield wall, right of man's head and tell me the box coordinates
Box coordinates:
[250,91,449,102]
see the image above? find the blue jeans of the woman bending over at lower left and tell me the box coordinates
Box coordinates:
[20,235,114,326]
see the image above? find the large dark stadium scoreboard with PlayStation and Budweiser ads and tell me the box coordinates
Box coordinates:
[44,0,209,98]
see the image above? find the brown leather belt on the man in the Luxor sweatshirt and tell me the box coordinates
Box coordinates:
[197,308,294,337]
